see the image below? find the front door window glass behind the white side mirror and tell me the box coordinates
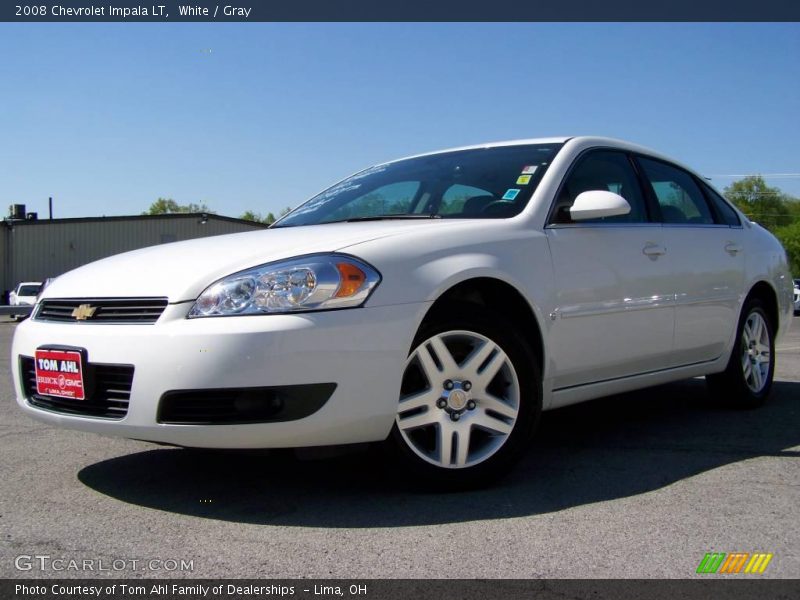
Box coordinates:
[551,150,647,223]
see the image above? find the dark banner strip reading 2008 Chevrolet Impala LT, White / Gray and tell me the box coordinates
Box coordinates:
[0,0,800,22]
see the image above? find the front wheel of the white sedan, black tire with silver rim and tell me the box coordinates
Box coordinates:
[387,305,542,490]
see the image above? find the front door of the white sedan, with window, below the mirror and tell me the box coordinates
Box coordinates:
[545,149,674,390]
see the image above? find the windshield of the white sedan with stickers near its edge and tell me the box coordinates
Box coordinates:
[274,144,562,227]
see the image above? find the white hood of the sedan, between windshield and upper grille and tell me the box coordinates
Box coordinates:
[41,219,457,302]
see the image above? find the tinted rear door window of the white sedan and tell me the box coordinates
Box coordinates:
[637,157,714,225]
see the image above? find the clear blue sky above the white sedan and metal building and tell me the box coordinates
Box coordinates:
[0,23,800,217]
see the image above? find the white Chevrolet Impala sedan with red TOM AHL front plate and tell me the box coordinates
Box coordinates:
[12,137,792,486]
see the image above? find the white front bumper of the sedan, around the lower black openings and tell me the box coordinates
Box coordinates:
[11,303,428,448]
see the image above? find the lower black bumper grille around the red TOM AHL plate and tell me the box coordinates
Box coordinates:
[19,356,133,419]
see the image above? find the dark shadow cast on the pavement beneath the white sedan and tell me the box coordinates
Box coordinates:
[78,380,800,527]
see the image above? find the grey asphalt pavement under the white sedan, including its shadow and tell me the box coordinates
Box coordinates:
[0,318,800,578]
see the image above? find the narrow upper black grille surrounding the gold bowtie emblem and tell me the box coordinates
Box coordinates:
[33,298,167,324]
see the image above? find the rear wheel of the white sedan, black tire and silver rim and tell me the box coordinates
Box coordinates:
[706,298,775,408]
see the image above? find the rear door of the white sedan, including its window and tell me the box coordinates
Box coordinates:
[636,157,744,366]
